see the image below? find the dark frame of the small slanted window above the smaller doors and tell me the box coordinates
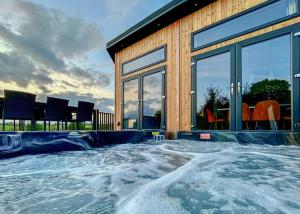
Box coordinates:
[121,44,168,76]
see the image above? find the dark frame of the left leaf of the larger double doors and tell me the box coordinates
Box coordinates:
[190,45,236,131]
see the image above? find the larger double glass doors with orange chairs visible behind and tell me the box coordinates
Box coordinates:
[191,25,300,131]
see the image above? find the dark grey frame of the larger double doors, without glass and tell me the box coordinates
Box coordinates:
[191,23,300,133]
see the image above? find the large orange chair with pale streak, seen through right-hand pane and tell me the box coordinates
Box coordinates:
[252,100,280,129]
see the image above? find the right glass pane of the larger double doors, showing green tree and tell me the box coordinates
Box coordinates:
[242,35,291,130]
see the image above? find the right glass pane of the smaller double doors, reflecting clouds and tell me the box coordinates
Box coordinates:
[143,72,162,129]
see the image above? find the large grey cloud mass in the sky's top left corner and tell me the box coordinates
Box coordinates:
[2,0,103,61]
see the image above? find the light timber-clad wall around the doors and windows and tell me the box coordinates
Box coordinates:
[115,0,300,131]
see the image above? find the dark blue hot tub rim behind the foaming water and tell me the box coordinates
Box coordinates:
[0,131,300,158]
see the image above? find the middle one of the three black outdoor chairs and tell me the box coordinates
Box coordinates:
[43,97,69,131]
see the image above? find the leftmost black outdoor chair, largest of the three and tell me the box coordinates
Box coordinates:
[2,90,36,131]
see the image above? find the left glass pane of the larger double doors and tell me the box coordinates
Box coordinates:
[196,52,230,130]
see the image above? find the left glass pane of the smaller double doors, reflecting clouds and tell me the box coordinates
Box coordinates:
[123,79,139,129]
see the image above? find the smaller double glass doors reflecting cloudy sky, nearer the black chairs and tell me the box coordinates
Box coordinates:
[123,68,165,130]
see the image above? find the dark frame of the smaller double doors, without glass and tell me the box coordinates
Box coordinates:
[121,66,167,131]
